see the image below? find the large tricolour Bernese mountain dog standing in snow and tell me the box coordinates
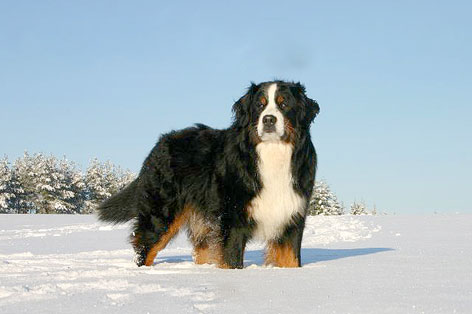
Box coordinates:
[98,81,319,268]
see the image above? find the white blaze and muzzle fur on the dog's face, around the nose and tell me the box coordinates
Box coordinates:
[257,83,285,141]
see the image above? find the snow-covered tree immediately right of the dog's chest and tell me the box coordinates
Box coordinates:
[308,181,344,215]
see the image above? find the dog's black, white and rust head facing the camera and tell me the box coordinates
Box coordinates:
[233,81,320,144]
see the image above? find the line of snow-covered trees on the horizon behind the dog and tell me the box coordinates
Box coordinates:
[0,152,376,215]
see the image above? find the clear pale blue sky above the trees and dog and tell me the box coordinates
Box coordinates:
[0,1,472,213]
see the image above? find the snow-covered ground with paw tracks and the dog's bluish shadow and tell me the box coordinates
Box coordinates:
[0,214,472,314]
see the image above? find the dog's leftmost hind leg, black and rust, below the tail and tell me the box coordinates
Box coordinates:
[131,207,190,266]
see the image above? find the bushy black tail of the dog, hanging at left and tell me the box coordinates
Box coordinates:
[97,178,139,224]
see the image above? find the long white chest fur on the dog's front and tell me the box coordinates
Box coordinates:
[250,142,305,240]
